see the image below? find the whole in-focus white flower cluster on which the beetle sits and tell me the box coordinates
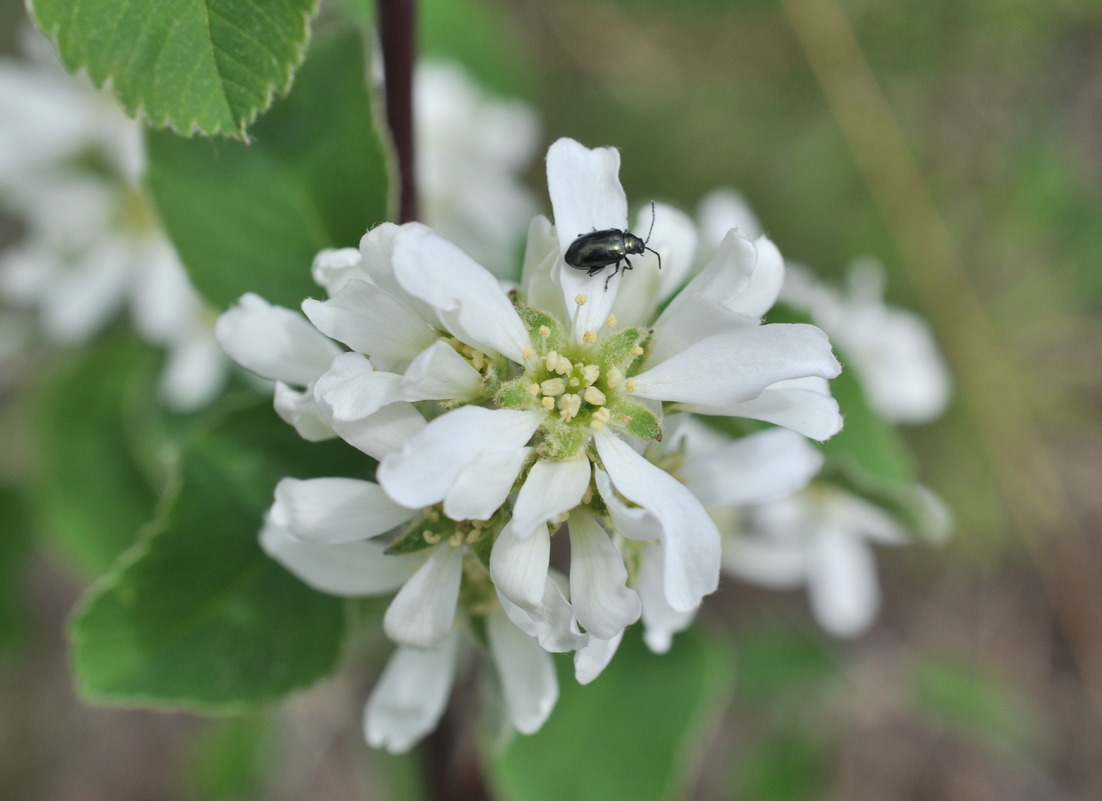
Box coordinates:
[217,139,841,751]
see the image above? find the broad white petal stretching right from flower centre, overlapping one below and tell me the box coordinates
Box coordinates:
[634,324,842,407]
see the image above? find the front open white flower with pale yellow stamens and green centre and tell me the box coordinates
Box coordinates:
[303,140,840,636]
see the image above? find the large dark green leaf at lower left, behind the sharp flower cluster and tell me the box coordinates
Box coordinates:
[72,402,369,711]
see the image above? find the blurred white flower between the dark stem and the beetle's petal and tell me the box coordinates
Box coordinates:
[413,62,540,278]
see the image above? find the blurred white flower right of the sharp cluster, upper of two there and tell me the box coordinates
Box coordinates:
[782,259,951,423]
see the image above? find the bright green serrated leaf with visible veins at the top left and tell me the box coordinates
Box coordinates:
[29,0,316,140]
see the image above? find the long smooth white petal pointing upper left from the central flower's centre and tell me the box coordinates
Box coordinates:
[395,226,530,364]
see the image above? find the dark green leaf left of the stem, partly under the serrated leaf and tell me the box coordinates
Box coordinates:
[147,34,389,309]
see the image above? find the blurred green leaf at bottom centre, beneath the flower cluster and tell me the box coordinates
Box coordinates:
[490,631,734,801]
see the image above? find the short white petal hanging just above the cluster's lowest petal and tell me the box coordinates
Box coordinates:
[382,544,466,648]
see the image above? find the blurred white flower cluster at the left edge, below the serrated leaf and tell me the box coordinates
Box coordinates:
[0,28,228,411]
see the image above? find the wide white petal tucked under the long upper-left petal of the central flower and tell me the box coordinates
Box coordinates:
[302,280,436,361]
